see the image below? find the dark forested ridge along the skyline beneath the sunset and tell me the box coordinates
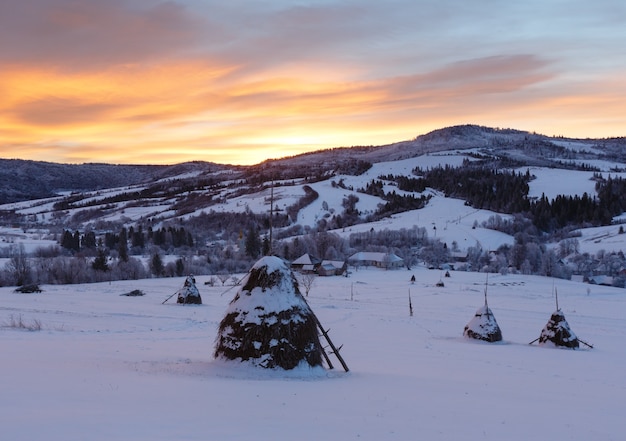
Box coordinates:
[0,125,626,210]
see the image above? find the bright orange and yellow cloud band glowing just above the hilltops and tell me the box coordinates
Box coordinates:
[0,48,618,164]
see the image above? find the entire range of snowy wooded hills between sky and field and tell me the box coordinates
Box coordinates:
[0,125,626,286]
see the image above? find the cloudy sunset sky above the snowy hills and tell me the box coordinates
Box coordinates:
[0,0,626,164]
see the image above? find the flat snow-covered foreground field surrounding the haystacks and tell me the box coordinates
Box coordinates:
[0,268,626,441]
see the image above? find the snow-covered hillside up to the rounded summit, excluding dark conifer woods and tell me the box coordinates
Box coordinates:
[0,122,626,266]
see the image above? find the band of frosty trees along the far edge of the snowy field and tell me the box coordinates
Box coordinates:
[0,219,626,286]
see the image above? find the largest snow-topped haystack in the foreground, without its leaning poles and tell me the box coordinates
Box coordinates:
[214,256,323,370]
